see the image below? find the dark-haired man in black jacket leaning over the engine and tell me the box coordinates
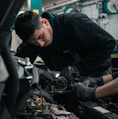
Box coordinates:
[15,11,115,76]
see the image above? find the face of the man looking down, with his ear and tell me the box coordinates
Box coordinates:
[28,18,53,47]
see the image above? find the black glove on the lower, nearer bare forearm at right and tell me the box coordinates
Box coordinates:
[72,84,96,100]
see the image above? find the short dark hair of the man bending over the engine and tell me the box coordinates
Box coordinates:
[15,11,41,42]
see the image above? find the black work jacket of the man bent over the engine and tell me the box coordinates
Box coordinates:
[17,13,115,76]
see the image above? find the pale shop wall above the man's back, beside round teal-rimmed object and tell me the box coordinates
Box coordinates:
[81,0,118,40]
